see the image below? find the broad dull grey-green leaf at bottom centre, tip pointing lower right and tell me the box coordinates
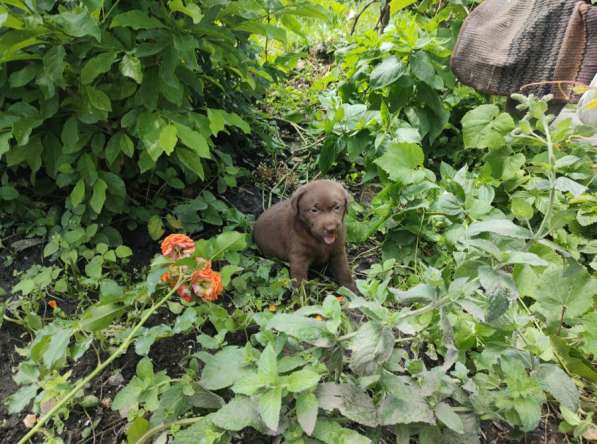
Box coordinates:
[317,383,379,427]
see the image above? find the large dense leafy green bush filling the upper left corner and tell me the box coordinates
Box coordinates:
[0,0,286,233]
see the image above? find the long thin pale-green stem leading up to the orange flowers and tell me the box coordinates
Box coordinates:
[18,283,180,444]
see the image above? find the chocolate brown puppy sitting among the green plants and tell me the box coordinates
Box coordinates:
[254,180,356,291]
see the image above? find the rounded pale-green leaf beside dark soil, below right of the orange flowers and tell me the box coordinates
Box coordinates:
[201,346,247,390]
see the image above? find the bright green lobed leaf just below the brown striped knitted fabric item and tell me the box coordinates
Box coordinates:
[461,105,515,149]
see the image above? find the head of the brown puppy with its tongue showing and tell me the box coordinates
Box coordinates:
[290,180,349,245]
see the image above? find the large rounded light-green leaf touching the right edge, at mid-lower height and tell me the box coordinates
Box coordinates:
[533,261,597,324]
